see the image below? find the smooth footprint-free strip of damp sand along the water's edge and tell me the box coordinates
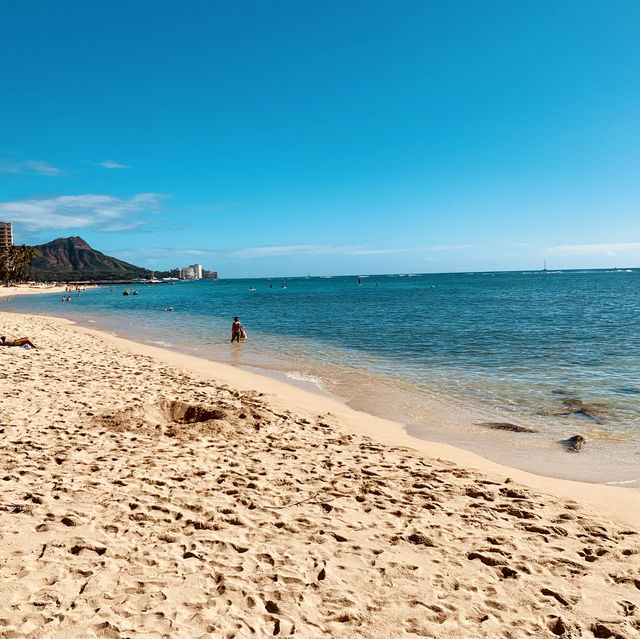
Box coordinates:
[10,312,640,529]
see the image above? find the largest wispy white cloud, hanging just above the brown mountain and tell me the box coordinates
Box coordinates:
[0,193,166,231]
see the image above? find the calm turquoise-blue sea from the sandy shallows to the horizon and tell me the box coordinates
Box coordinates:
[8,270,640,487]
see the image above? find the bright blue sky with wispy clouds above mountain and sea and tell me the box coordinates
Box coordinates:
[0,0,640,277]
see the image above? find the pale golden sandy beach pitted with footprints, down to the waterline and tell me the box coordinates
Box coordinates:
[0,313,640,639]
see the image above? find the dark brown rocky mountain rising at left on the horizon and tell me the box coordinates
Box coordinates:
[31,236,151,281]
